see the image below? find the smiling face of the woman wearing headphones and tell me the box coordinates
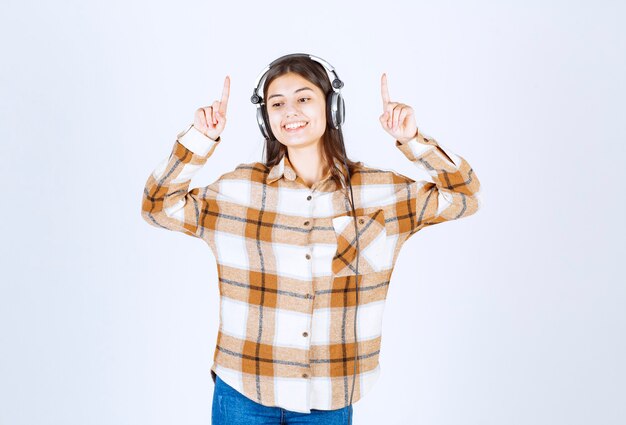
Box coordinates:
[266,72,326,151]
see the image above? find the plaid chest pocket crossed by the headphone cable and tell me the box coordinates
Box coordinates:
[332,209,387,276]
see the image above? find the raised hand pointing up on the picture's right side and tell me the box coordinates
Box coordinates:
[379,73,417,143]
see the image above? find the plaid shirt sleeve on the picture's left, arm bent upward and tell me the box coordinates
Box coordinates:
[141,124,221,238]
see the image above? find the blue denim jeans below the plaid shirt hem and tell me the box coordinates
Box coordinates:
[211,376,352,425]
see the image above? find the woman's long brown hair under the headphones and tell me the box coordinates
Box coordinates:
[263,57,363,188]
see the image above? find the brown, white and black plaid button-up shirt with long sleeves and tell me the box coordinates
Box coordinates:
[142,125,480,413]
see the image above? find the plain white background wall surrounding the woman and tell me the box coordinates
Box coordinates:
[0,0,626,425]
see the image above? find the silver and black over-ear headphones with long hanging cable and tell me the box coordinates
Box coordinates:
[250,53,361,423]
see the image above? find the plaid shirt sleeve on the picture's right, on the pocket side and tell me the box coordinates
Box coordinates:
[394,126,481,239]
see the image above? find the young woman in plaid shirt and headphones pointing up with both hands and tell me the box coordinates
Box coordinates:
[142,54,480,425]
